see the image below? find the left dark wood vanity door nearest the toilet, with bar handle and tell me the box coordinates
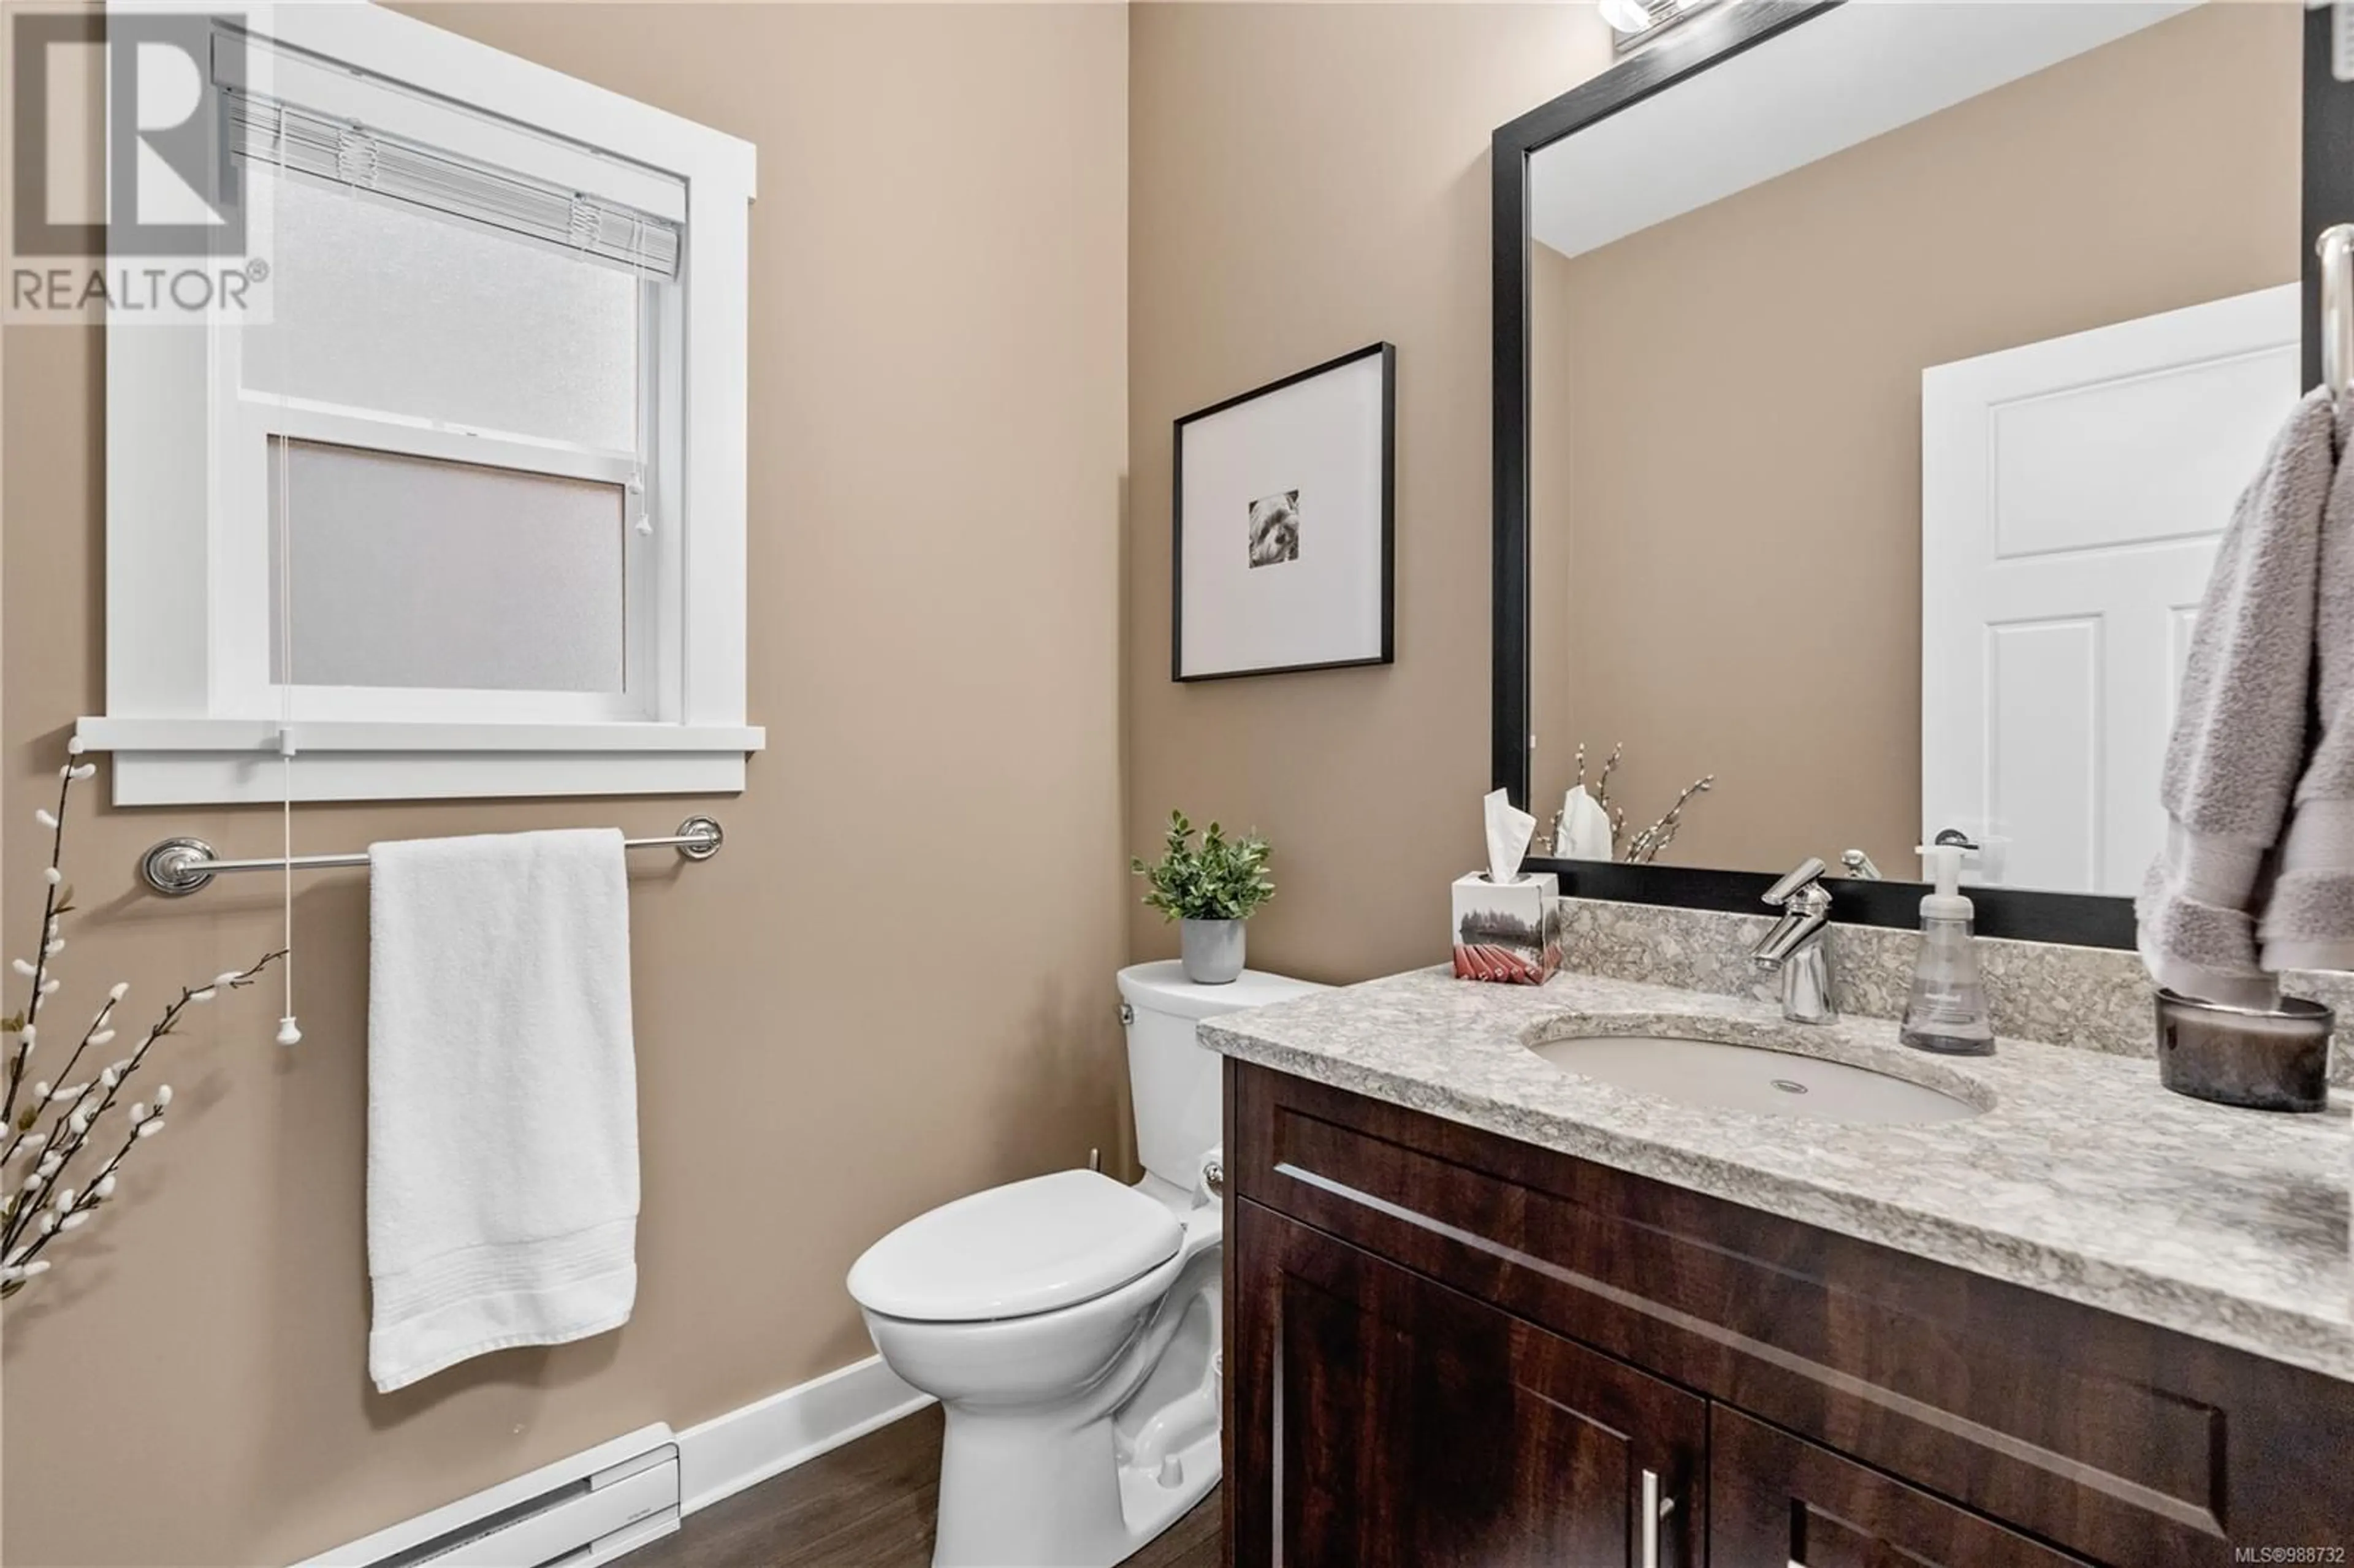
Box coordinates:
[1227,1203,1707,1568]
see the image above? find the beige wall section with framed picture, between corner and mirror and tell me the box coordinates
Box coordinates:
[1127,5,1608,980]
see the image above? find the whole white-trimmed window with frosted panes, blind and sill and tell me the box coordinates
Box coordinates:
[80,5,763,805]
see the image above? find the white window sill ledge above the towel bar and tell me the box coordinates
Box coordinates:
[75,718,768,805]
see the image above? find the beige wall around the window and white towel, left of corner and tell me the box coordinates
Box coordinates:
[0,5,1127,1566]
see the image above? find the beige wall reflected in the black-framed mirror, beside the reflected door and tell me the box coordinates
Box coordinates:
[1533,5,2303,876]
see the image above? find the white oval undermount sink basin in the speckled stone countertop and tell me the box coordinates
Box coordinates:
[1530,1033,1982,1128]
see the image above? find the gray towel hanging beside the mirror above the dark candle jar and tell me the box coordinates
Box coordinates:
[2135,391,2354,1008]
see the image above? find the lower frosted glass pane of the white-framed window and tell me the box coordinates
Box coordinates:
[271,440,626,692]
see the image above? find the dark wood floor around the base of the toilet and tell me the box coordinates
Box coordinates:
[626,1406,1222,1568]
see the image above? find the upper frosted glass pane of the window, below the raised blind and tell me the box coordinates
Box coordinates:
[245,165,640,452]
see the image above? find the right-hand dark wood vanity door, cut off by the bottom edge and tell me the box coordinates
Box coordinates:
[1709,1406,2085,1568]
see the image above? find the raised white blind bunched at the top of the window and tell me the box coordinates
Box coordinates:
[226,92,680,280]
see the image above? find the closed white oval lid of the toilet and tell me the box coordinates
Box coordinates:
[850,1170,1184,1323]
